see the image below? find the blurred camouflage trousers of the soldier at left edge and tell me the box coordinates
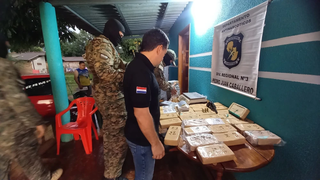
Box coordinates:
[0,126,51,180]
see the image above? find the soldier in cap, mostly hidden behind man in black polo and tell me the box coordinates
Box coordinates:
[154,49,177,95]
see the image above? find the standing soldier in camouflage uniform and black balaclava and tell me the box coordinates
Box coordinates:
[84,19,128,180]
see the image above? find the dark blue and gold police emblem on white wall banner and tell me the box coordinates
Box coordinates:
[223,33,243,69]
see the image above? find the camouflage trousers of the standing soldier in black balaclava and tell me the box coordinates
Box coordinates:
[96,99,128,179]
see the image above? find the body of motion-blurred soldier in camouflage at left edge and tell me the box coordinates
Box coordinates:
[0,58,62,180]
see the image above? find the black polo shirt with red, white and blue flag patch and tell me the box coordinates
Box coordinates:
[123,53,160,146]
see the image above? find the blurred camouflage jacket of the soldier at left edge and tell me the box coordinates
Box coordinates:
[0,58,45,136]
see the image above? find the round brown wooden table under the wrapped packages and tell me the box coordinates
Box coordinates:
[177,142,274,180]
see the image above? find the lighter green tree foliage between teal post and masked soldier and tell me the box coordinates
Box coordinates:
[60,30,93,57]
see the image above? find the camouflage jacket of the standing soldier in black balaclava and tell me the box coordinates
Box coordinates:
[84,35,125,100]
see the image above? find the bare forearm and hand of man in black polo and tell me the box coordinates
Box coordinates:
[134,108,165,159]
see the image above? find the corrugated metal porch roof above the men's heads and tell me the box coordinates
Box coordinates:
[57,1,189,36]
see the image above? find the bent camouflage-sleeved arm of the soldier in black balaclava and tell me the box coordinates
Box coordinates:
[94,43,125,82]
